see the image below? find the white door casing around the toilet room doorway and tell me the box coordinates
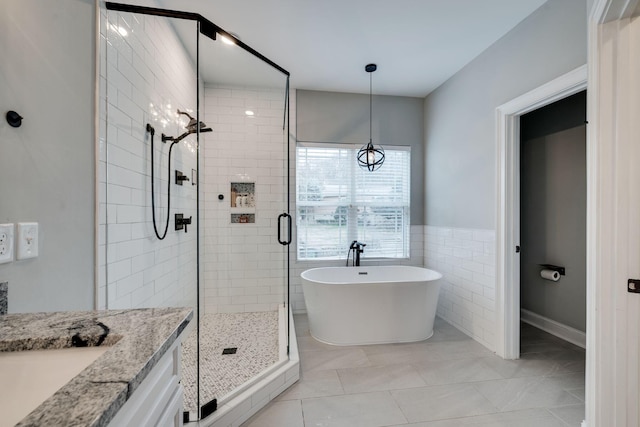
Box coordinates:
[496,65,587,359]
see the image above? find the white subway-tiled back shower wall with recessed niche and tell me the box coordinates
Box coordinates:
[200,85,295,313]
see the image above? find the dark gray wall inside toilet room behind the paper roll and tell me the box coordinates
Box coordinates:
[520,92,587,331]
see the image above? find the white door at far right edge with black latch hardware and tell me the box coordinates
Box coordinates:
[586,9,640,427]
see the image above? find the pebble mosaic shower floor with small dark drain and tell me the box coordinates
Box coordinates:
[182,311,279,415]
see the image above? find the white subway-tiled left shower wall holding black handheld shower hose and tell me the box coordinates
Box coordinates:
[98,9,197,309]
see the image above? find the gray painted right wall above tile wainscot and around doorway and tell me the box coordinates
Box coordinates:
[425,0,587,229]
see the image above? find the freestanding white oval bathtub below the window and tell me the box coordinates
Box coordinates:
[301,266,442,345]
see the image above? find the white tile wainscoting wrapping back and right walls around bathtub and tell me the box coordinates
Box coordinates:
[291,225,496,351]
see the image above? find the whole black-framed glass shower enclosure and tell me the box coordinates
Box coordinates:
[98,2,291,421]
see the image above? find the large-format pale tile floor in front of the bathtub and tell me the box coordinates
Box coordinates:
[243,315,585,427]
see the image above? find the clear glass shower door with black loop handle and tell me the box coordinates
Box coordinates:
[190,19,291,418]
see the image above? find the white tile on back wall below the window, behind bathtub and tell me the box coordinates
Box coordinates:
[291,226,424,313]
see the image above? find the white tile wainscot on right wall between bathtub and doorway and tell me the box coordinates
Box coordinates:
[424,226,496,350]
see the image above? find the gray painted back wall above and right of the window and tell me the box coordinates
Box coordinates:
[296,90,424,225]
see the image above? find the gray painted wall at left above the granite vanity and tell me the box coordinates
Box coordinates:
[0,0,95,312]
